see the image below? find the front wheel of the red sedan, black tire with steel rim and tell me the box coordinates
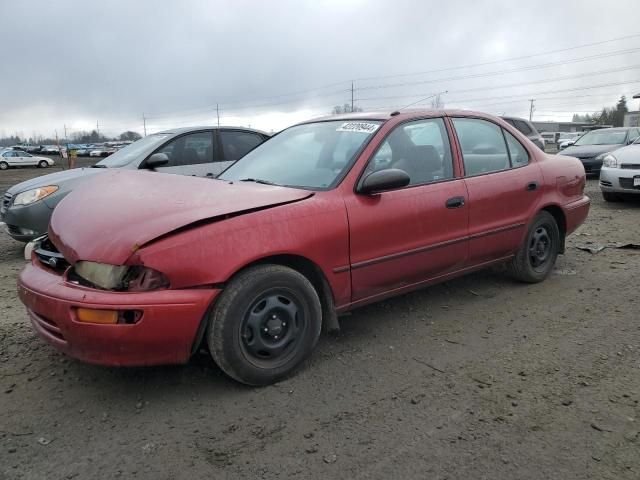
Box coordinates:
[207,265,322,386]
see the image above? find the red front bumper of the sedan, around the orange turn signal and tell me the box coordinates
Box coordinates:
[18,260,220,366]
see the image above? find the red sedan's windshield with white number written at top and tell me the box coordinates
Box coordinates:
[218,120,382,190]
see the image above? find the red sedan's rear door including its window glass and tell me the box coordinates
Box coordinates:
[452,118,543,264]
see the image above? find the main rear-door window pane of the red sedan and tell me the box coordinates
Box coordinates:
[453,118,510,176]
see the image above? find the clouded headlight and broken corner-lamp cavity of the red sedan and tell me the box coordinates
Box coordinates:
[69,261,169,292]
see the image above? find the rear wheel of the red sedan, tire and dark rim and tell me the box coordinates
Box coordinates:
[507,211,560,283]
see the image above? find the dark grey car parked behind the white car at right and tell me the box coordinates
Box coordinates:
[562,127,640,174]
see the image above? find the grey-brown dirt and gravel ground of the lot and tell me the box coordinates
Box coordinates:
[0,162,640,480]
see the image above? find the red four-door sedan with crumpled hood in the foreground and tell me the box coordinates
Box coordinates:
[18,111,589,385]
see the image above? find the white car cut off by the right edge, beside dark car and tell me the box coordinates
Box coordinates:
[600,138,640,202]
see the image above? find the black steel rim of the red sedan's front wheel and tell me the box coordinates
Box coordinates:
[240,289,307,368]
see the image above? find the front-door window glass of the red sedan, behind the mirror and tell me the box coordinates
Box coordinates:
[365,118,453,185]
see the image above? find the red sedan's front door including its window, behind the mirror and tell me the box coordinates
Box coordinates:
[346,118,469,302]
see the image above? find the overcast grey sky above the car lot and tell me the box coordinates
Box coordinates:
[0,0,640,141]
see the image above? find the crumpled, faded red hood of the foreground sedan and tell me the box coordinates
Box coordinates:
[49,169,313,265]
